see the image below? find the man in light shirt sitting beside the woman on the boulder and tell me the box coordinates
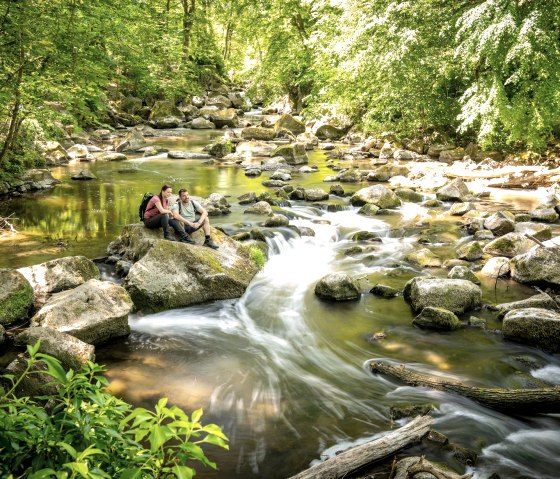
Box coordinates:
[169,188,218,249]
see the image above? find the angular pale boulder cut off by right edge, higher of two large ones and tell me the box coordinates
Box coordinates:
[510,243,560,286]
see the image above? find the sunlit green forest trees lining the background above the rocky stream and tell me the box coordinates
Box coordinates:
[0,0,560,174]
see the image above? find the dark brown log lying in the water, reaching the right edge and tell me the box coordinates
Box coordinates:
[370,361,560,414]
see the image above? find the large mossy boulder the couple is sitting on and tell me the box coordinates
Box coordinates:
[121,231,259,312]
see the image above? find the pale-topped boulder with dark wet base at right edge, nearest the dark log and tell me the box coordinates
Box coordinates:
[502,308,560,353]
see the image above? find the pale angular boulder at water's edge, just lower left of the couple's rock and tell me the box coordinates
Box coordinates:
[31,279,132,344]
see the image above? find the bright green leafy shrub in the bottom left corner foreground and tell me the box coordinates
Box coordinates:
[0,343,228,479]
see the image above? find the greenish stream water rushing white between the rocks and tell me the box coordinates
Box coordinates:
[0,122,560,479]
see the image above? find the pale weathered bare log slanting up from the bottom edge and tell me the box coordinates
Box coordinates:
[290,416,433,479]
